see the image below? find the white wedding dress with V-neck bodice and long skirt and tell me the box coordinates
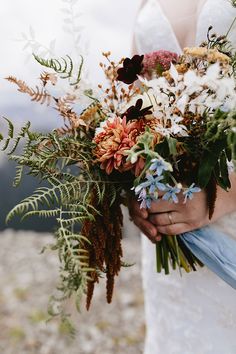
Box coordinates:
[135,0,236,354]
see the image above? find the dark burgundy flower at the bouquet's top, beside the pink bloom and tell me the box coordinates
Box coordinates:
[117,54,144,84]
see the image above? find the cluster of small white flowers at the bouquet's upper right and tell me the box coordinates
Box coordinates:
[141,57,236,136]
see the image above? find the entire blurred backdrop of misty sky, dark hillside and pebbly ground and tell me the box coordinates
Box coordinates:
[0,0,145,354]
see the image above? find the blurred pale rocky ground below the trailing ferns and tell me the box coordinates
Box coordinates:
[0,223,145,354]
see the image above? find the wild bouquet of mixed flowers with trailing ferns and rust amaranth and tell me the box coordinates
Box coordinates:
[3,27,236,314]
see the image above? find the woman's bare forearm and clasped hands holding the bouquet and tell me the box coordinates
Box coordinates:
[129,173,236,242]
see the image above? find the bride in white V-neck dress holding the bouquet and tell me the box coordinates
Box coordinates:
[130,0,236,354]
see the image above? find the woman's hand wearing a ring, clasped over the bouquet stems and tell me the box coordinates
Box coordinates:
[148,191,210,235]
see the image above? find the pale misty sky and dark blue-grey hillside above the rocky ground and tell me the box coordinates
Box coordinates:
[0,0,140,231]
